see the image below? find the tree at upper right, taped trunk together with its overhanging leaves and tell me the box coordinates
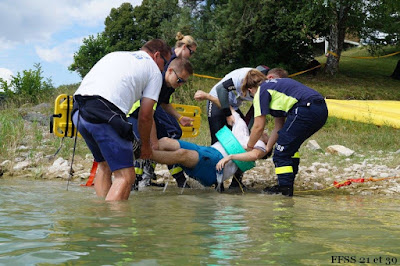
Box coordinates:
[324,0,400,75]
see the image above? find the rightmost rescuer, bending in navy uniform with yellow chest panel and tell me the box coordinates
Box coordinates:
[242,69,328,196]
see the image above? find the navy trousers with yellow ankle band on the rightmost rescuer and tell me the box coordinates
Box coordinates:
[273,102,328,186]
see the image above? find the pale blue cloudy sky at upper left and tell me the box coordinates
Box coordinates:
[0,0,142,86]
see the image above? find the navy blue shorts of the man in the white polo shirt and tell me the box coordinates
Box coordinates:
[72,111,133,172]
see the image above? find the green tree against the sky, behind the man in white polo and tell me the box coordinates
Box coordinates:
[68,0,180,78]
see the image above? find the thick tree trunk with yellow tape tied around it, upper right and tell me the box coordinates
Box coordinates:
[325,3,349,75]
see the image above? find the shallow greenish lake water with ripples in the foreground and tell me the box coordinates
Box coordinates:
[0,179,400,265]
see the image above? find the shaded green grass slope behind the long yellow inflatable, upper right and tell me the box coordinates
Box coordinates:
[294,48,400,100]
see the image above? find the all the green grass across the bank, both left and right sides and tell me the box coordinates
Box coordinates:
[0,45,400,166]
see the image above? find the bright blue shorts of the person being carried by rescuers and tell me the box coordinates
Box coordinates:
[178,140,224,187]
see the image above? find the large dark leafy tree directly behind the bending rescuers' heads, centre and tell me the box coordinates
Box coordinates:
[188,0,324,72]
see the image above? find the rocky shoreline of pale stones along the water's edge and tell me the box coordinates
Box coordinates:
[0,106,400,195]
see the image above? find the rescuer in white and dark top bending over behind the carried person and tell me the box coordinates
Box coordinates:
[194,65,288,188]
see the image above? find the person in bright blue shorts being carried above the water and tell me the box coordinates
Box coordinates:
[152,110,268,187]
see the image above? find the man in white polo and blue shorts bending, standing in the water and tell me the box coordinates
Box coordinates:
[73,39,171,200]
